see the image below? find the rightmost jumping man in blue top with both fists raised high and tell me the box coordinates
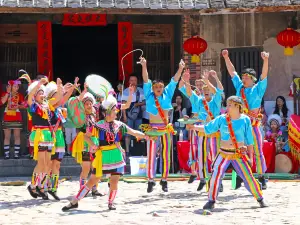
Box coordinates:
[222,50,269,189]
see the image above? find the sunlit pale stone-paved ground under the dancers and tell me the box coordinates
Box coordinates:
[0,179,300,225]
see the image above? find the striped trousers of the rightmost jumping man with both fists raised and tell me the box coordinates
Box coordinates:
[252,126,267,175]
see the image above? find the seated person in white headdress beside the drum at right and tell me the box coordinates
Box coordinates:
[265,114,286,153]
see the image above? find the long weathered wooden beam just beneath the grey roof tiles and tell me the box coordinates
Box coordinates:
[0,5,300,15]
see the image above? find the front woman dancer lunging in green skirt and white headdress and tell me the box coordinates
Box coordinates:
[62,95,148,211]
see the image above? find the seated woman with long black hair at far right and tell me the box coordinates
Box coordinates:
[273,96,289,139]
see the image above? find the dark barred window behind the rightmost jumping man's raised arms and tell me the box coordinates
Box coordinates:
[221,46,263,98]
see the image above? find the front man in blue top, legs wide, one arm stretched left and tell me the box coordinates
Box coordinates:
[187,96,267,210]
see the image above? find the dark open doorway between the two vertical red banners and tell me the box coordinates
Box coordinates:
[52,24,118,88]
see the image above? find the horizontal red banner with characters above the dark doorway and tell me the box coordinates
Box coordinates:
[62,13,107,26]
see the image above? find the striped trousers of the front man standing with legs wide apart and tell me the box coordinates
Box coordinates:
[208,154,263,201]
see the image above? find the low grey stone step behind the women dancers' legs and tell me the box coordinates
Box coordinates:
[0,157,130,177]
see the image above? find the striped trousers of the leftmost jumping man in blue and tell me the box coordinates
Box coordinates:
[147,133,172,180]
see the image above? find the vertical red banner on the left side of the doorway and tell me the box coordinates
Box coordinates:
[37,21,53,81]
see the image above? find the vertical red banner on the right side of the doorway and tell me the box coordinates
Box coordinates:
[118,22,133,81]
